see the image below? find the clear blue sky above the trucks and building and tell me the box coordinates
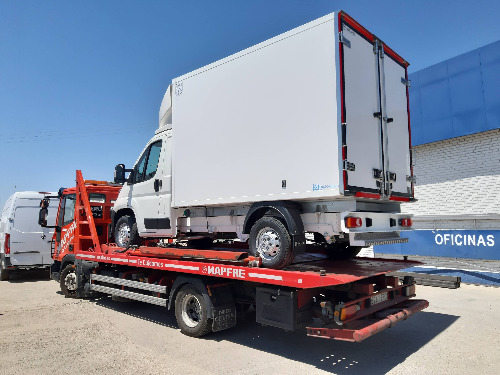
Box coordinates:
[0,0,500,207]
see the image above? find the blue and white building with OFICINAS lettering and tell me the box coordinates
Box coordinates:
[374,41,500,259]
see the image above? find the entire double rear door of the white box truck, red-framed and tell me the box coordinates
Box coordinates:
[339,13,412,200]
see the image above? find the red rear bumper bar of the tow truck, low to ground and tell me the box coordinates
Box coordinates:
[307,300,429,342]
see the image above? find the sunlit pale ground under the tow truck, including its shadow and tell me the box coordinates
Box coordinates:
[0,273,500,375]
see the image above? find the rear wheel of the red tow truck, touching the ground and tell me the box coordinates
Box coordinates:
[175,284,212,337]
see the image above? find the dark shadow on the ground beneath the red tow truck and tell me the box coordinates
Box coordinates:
[96,297,459,375]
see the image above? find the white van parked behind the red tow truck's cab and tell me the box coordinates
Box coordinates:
[0,191,57,281]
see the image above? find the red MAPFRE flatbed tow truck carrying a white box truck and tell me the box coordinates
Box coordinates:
[40,171,429,342]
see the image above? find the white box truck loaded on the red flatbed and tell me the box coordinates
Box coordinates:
[113,11,414,268]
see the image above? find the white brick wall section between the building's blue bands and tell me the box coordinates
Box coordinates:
[402,129,500,229]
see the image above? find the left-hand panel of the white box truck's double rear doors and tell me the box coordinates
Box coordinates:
[340,17,383,194]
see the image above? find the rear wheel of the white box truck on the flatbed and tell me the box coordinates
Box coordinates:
[248,216,293,269]
